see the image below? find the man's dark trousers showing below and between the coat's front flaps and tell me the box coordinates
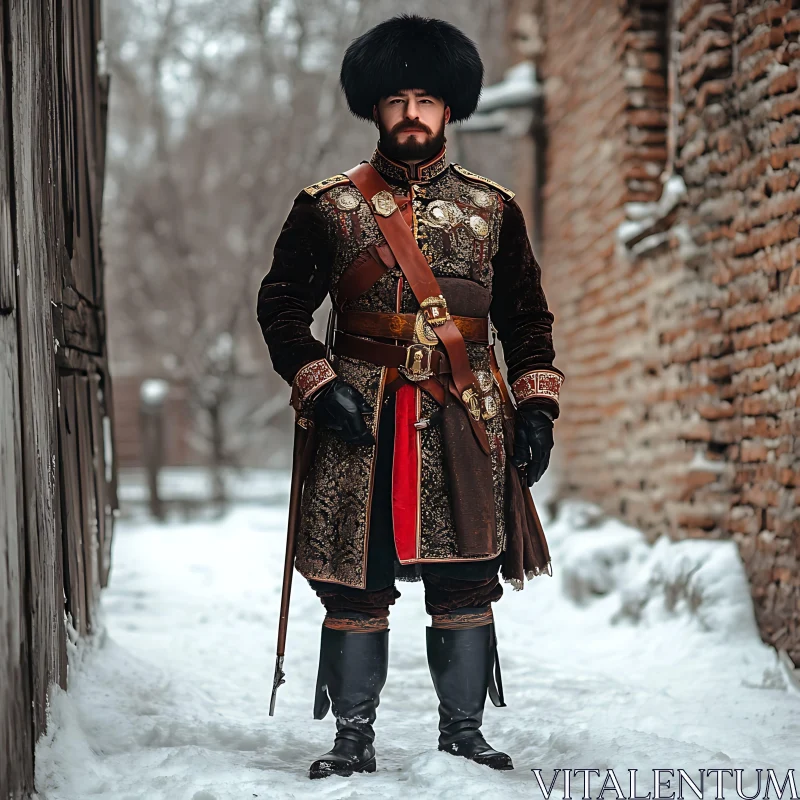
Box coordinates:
[308,395,503,622]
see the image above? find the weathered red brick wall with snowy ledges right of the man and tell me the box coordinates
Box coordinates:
[540,0,800,662]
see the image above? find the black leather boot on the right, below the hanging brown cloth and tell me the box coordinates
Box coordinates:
[426,623,514,769]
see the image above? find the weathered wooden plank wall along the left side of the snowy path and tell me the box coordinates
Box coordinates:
[0,0,117,798]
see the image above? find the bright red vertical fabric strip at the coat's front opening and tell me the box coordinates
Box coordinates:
[392,383,419,561]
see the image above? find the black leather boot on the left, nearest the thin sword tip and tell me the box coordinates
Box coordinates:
[309,625,389,778]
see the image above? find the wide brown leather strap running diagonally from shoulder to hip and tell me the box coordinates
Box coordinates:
[345,162,489,454]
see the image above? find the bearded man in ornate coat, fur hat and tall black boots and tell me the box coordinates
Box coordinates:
[258,15,564,778]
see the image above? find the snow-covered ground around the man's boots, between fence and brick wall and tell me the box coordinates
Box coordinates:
[36,482,800,800]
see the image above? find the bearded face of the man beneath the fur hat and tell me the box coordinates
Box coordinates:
[373,89,450,162]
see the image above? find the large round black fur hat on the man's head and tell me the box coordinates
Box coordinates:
[339,14,483,122]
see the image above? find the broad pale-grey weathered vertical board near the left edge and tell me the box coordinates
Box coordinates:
[4,0,67,737]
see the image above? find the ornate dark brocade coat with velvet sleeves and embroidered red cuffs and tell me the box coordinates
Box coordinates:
[257,151,564,588]
